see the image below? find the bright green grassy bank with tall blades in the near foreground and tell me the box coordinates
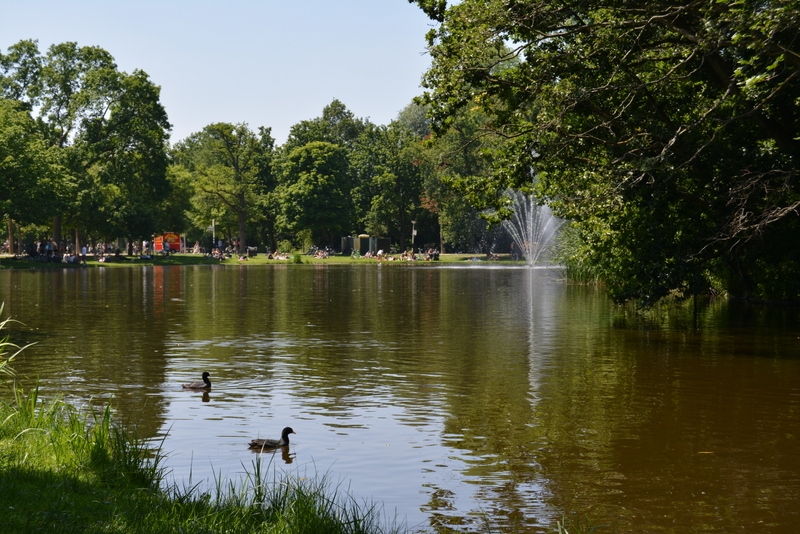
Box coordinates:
[0,390,399,534]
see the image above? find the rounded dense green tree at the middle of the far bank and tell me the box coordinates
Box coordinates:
[279,141,353,246]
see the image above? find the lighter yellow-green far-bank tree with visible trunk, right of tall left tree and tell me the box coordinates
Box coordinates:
[175,123,274,254]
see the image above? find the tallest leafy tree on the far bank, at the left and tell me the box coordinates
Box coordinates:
[0,40,170,249]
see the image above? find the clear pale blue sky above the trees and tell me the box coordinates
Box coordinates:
[0,0,433,144]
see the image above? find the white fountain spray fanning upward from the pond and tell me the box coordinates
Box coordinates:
[503,189,564,267]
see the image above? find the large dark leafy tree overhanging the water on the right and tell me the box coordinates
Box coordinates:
[410,0,800,303]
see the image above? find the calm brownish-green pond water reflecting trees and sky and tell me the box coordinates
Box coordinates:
[0,264,800,533]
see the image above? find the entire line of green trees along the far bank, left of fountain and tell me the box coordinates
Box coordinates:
[0,40,500,264]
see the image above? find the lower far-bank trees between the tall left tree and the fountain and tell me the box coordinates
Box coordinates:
[169,95,506,258]
